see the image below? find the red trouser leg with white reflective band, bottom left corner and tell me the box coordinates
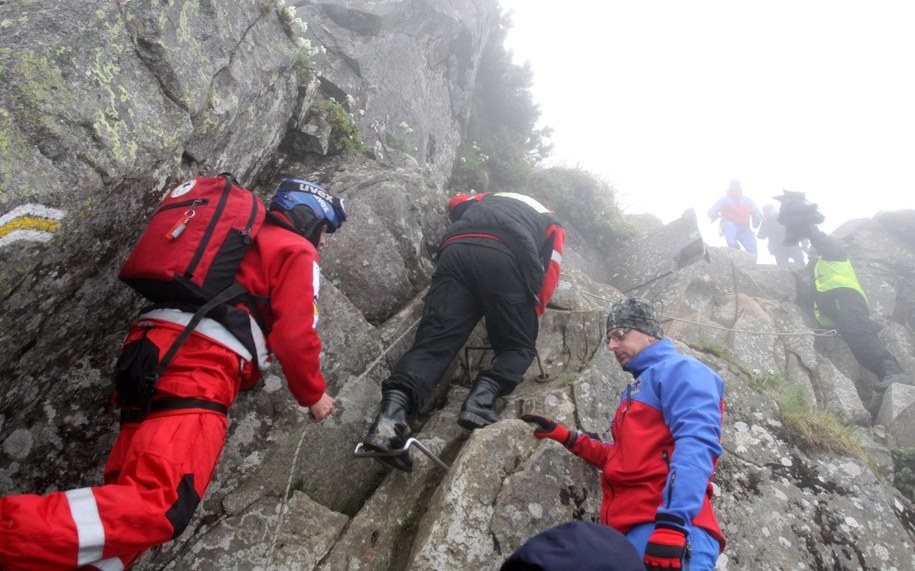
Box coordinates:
[0,411,226,570]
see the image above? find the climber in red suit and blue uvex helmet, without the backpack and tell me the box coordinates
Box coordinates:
[0,179,346,571]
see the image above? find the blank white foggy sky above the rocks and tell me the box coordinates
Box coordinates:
[499,0,915,255]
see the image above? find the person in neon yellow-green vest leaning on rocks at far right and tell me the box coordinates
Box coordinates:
[777,193,911,418]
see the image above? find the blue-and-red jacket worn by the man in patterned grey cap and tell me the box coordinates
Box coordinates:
[569,339,725,550]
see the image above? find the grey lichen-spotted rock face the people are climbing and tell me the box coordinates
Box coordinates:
[0,0,915,571]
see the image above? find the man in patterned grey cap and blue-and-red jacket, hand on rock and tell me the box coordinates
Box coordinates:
[521,298,725,571]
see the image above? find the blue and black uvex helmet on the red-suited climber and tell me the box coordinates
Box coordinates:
[270,178,346,246]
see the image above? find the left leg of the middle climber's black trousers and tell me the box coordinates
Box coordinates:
[381,243,485,410]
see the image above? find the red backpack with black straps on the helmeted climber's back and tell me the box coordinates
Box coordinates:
[115,173,266,407]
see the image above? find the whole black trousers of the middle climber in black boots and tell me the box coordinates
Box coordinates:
[381,241,539,410]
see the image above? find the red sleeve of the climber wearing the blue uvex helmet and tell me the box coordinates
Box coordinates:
[268,248,327,406]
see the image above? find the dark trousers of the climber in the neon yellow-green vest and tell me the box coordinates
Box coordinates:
[815,288,903,381]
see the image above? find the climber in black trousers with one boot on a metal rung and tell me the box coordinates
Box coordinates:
[363,192,565,472]
